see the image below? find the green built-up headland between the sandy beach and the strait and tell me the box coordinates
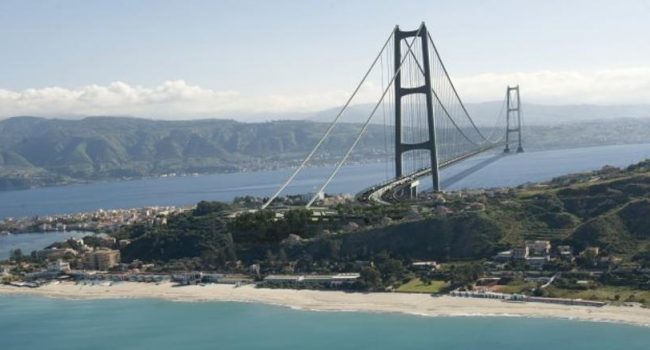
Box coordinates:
[0,162,650,306]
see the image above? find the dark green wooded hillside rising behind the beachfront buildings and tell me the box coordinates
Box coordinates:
[114,162,650,272]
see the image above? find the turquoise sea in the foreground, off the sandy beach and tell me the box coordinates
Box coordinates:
[0,296,650,350]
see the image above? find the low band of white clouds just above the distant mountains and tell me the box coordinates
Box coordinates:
[0,67,650,119]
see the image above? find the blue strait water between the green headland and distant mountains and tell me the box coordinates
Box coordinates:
[0,144,650,218]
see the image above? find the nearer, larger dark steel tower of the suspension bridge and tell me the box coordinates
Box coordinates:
[394,23,440,195]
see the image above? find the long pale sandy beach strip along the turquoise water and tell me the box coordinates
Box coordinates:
[0,282,650,327]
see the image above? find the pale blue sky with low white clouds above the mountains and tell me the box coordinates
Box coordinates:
[0,0,650,119]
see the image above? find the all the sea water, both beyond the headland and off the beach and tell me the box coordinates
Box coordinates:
[0,144,650,350]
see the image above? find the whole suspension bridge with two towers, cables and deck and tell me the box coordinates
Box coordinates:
[262,23,524,209]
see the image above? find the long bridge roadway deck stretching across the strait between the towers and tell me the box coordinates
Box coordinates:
[356,142,504,205]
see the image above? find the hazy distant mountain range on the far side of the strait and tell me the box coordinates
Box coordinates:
[0,115,650,190]
